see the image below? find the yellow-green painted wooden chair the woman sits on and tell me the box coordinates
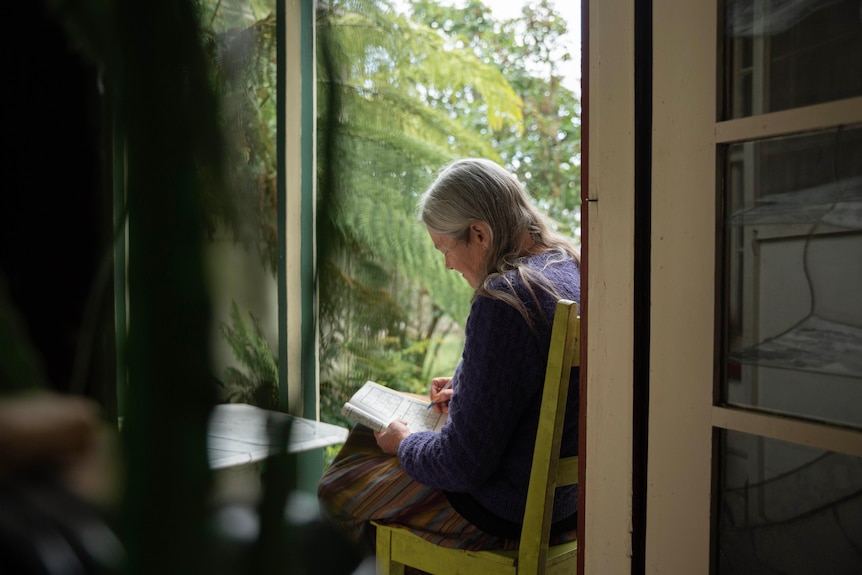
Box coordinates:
[375,300,580,575]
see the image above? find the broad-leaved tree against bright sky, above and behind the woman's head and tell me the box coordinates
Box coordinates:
[411,0,581,237]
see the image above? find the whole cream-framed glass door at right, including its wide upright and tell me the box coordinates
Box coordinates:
[648,0,862,575]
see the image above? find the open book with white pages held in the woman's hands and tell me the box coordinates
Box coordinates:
[341,381,446,431]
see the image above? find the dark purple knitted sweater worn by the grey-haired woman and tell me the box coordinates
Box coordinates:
[398,252,581,526]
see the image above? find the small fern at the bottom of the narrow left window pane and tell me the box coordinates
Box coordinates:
[219,301,278,409]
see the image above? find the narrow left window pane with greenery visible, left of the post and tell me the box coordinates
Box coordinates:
[197,0,279,409]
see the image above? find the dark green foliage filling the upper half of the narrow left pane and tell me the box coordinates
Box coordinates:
[199,0,278,275]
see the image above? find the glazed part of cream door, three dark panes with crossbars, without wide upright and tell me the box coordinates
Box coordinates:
[713,0,862,575]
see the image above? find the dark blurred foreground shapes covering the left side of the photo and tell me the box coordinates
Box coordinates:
[0,0,370,575]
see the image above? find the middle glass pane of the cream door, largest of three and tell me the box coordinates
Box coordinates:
[722,126,862,427]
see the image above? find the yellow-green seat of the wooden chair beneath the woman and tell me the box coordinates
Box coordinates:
[373,522,578,575]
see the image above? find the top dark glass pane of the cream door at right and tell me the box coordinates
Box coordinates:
[724,0,862,118]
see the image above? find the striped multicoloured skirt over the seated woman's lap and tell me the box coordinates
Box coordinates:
[317,425,518,551]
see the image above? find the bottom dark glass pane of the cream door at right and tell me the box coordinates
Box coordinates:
[716,431,862,575]
